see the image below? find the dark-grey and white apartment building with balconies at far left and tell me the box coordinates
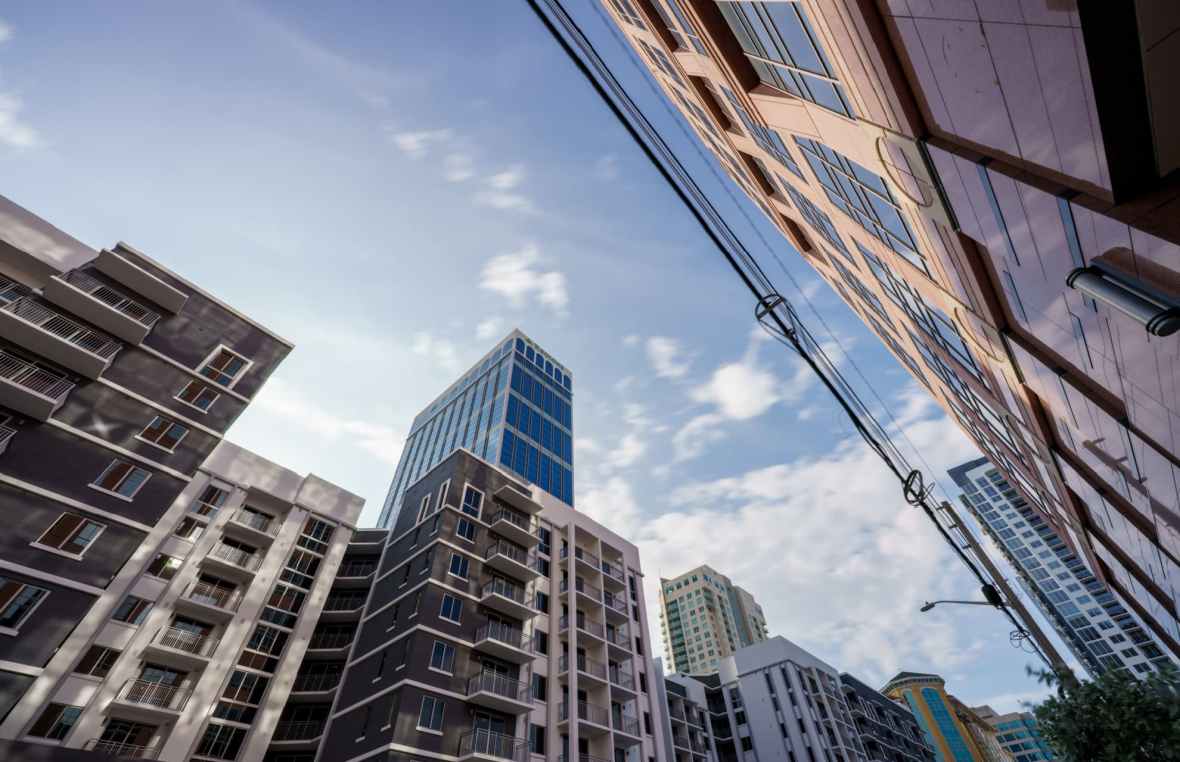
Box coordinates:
[0,199,362,760]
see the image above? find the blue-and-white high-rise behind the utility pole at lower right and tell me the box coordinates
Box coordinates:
[949,458,1171,675]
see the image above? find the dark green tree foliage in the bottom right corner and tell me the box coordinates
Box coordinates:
[1029,669,1180,762]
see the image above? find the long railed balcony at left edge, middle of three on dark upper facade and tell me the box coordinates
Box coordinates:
[0,296,123,379]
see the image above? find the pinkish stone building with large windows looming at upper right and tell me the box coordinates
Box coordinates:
[603,0,1180,653]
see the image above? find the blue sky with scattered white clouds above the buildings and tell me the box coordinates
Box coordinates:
[0,0,1071,709]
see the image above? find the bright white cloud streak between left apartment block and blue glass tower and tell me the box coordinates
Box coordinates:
[254,379,405,466]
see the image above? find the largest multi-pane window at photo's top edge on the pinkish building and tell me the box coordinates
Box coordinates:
[717,2,854,118]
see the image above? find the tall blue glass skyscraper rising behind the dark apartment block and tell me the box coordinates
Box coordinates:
[378,330,573,527]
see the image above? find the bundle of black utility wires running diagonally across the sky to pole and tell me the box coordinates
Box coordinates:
[529,0,1073,678]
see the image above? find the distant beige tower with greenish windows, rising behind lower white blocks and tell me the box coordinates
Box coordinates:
[660,565,767,675]
